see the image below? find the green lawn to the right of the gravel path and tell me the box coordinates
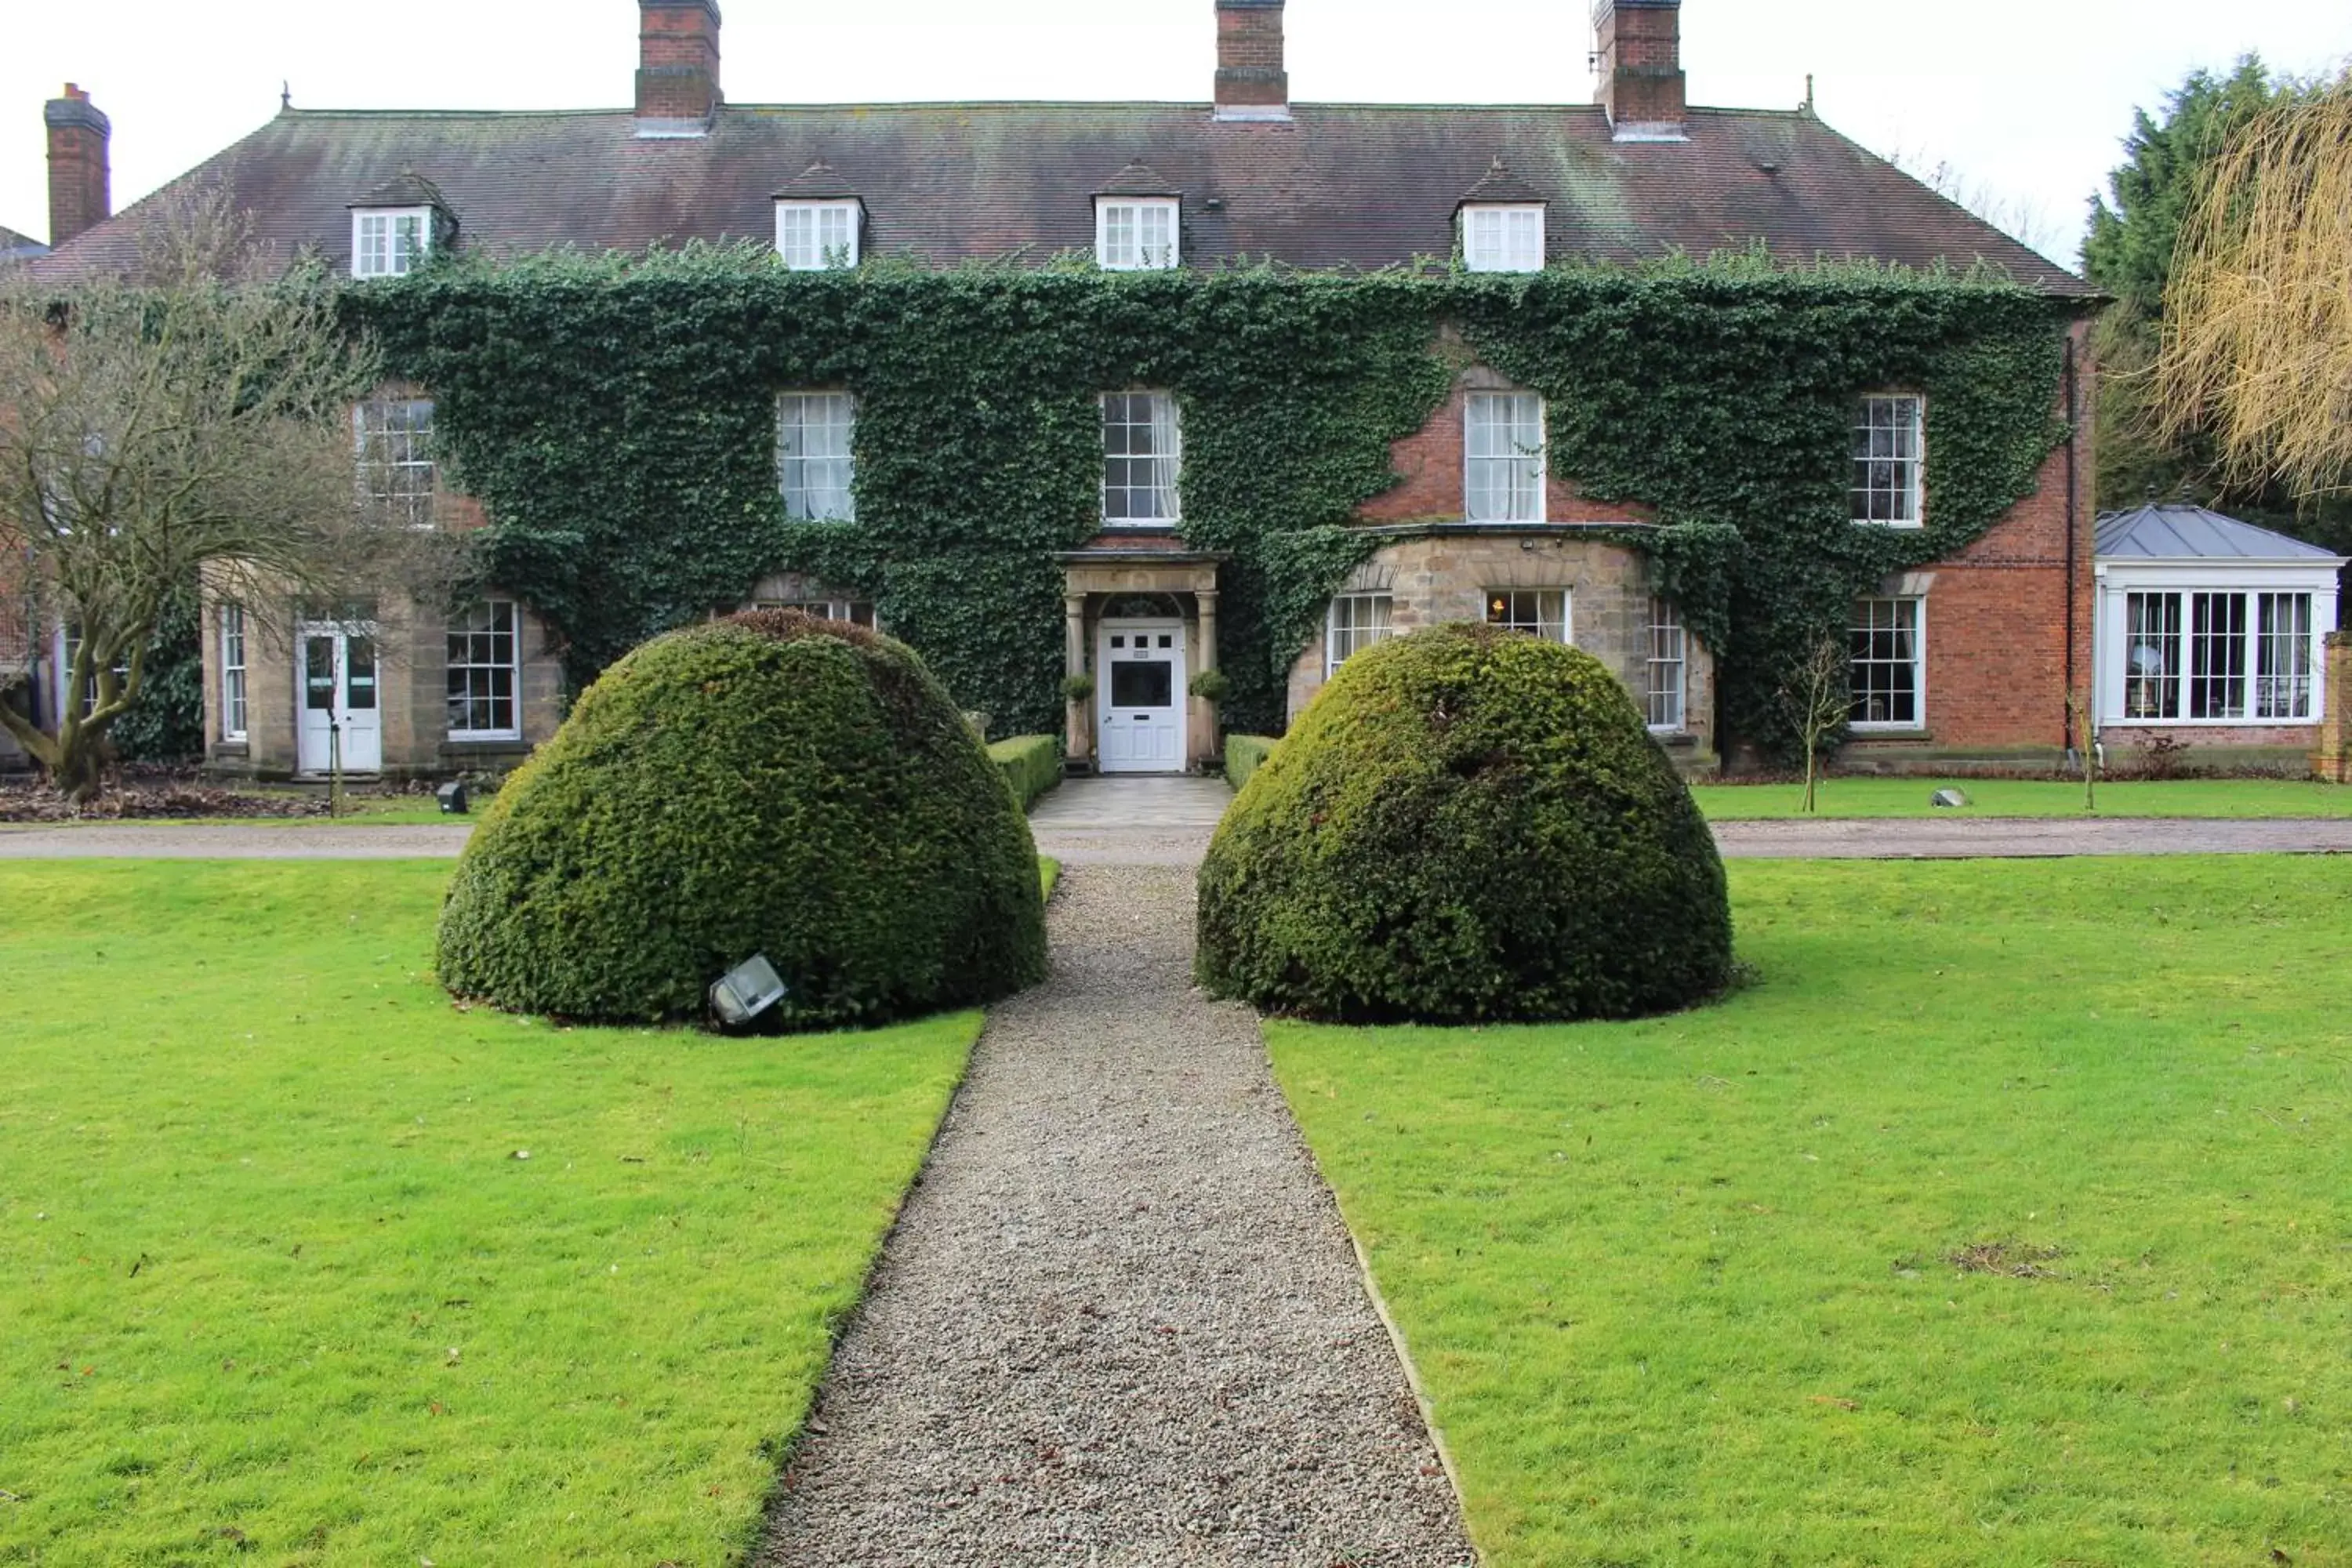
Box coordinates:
[1268,858,2352,1568]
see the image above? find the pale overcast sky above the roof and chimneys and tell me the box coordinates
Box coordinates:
[0,0,2352,263]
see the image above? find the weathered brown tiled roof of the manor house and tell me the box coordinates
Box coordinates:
[27,103,2093,296]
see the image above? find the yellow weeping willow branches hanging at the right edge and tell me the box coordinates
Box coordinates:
[2157,73,2352,496]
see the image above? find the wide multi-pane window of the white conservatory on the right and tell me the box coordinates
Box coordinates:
[2124,593,2314,722]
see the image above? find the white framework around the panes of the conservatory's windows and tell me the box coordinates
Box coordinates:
[2098,564,2338,731]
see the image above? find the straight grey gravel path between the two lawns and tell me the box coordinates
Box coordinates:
[757,865,1475,1568]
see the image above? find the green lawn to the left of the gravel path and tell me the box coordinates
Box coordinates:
[0,862,978,1568]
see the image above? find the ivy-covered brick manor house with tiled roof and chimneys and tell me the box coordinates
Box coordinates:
[32,0,2091,774]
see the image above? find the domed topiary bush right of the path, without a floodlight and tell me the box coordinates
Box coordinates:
[1200,626,1731,1022]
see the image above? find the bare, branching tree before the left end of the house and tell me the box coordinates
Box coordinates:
[0,191,452,799]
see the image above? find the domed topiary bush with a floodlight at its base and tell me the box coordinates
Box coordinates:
[440,612,1044,1029]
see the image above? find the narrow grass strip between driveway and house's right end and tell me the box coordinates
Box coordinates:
[1691,779,2352,822]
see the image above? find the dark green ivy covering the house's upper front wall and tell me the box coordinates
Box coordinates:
[350,247,2067,746]
